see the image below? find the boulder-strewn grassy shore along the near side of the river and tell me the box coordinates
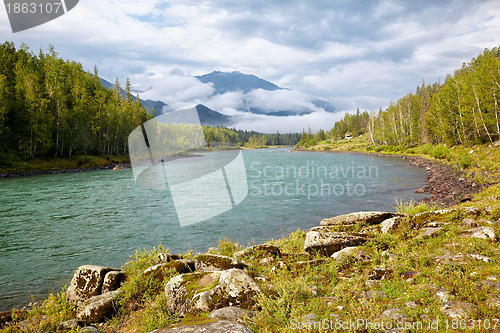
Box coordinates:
[2,206,500,333]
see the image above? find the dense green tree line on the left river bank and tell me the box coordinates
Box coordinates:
[0,42,151,160]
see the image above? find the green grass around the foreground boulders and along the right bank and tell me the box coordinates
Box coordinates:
[2,139,500,332]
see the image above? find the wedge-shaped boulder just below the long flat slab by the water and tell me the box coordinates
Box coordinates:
[304,227,369,256]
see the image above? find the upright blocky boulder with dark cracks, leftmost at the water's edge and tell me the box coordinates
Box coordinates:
[66,265,119,303]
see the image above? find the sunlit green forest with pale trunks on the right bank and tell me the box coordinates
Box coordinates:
[328,47,500,146]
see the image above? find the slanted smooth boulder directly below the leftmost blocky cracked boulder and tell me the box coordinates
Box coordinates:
[76,289,122,324]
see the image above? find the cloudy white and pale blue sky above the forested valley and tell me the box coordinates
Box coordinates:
[0,0,500,132]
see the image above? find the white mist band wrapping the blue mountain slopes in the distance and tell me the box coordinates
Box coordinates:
[111,71,340,133]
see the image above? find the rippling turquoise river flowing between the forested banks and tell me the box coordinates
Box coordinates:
[0,149,426,311]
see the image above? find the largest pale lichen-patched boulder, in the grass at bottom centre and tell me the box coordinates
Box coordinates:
[165,268,261,316]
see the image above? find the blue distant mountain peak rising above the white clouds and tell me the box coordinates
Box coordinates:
[195,71,281,95]
